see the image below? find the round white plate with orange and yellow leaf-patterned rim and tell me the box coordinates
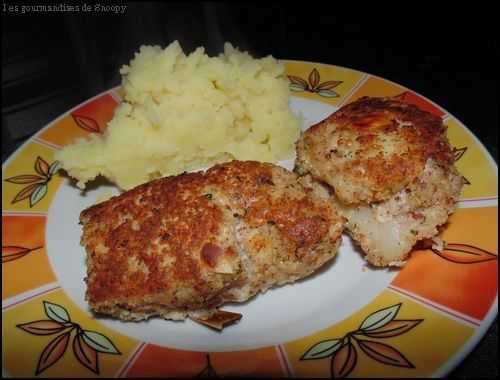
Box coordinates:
[2,61,498,377]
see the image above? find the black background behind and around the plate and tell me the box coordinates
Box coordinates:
[2,2,498,378]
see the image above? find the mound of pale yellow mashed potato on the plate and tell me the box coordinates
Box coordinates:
[56,41,300,190]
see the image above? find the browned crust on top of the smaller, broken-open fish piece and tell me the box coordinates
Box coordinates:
[297,97,453,204]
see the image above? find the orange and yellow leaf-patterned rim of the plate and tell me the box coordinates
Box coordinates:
[2,61,498,377]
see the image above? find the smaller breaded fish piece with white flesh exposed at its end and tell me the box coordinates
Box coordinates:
[295,97,463,266]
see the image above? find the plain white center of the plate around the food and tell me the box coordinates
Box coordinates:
[46,97,397,351]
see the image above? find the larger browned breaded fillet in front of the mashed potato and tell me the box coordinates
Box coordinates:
[80,161,344,319]
